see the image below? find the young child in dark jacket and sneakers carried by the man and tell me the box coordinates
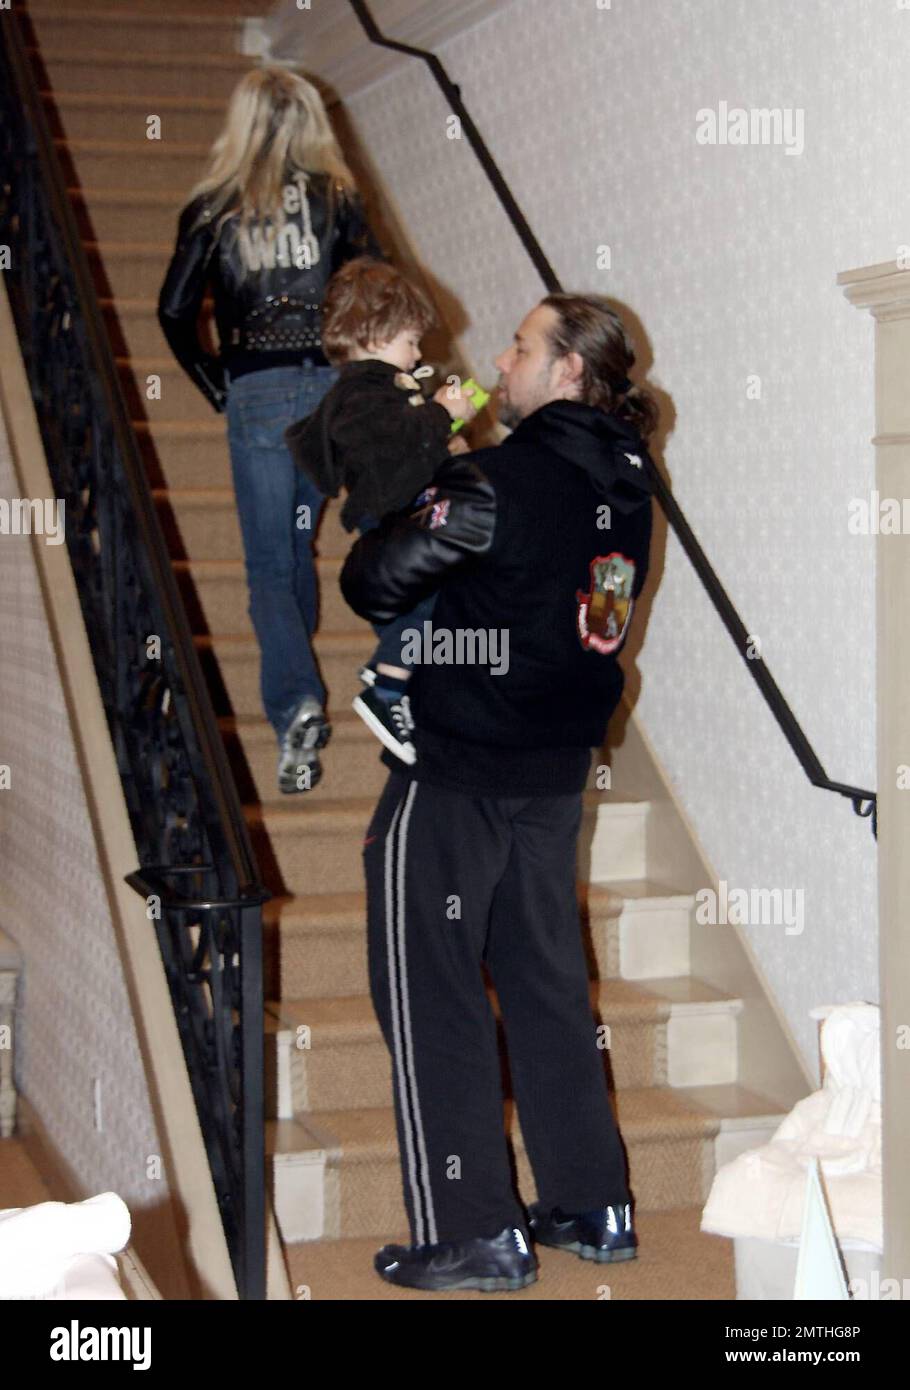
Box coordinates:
[285,256,477,763]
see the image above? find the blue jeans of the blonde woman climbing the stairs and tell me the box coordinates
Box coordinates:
[228,363,338,738]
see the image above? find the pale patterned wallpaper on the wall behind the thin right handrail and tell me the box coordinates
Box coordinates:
[349,0,910,1074]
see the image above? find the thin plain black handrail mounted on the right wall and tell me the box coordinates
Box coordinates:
[350,0,877,835]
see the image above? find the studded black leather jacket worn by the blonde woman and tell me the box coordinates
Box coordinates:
[158,174,383,411]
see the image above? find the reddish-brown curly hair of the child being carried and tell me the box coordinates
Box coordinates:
[322,256,436,364]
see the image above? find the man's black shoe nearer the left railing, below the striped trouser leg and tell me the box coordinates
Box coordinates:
[374,1226,538,1294]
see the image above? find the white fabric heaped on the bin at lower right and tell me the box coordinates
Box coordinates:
[702,1004,882,1250]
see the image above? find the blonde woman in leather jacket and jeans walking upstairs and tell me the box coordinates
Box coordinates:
[158,67,382,792]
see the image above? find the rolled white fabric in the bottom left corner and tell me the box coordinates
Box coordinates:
[0,1193,131,1298]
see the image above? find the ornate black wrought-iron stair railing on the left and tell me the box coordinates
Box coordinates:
[0,13,270,1298]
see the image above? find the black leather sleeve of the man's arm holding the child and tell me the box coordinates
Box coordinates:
[340,455,496,623]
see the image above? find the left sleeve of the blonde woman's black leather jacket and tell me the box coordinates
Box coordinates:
[158,202,228,411]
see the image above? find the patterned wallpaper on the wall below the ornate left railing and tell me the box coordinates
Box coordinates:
[0,405,168,1216]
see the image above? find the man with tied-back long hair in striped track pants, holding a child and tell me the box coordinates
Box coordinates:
[342,295,656,1290]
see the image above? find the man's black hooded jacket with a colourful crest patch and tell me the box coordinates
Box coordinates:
[342,400,652,796]
